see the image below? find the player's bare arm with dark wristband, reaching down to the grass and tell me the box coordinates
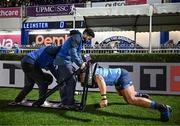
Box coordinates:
[95,75,107,108]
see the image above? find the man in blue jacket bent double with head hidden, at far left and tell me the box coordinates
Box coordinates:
[15,46,61,103]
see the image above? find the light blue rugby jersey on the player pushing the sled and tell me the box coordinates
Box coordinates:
[95,67,121,86]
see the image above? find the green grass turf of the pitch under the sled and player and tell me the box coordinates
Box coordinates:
[0,88,180,126]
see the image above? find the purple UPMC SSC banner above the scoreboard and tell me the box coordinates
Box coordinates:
[26,3,85,16]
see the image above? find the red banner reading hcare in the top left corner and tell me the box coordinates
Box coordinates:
[0,7,21,18]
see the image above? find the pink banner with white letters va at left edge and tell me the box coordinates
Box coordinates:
[0,34,21,48]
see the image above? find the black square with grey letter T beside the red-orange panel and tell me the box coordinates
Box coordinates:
[140,66,166,91]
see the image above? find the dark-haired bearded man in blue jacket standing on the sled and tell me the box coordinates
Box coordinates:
[55,28,95,107]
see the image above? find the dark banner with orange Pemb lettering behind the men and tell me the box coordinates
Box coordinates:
[29,34,68,46]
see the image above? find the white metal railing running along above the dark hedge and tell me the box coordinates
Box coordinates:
[0,44,180,54]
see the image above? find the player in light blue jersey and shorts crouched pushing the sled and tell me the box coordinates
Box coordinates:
[80,64,172,121]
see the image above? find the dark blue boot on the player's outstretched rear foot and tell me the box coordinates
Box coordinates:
[161,105,172,122]
